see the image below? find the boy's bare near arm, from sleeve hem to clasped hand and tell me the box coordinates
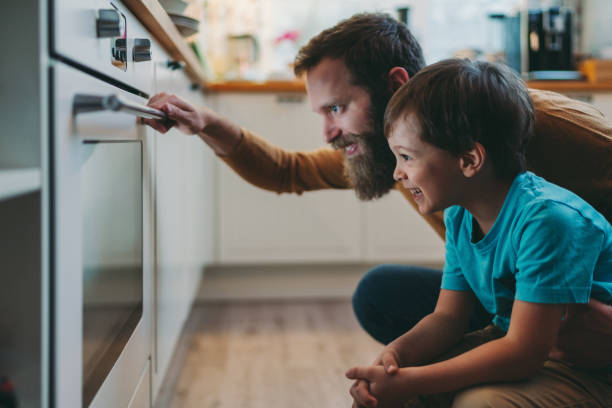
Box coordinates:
[347,300,564,406]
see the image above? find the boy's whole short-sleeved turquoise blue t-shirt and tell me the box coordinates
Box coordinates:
[442,172,612,331]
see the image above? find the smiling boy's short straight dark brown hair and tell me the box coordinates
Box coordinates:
[384,59,534,179]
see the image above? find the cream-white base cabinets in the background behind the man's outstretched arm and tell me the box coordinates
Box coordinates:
[210,93,444,264]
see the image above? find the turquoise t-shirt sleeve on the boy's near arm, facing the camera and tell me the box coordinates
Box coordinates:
[513,201,604,303]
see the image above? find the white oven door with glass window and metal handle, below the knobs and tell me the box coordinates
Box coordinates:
[50,63,154,407]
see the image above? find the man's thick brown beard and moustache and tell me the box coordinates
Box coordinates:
[332,115,395,201]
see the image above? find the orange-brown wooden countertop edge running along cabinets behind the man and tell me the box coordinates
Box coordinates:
[123,0,612,92]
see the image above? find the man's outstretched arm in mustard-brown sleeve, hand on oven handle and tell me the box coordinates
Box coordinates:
[145,93,351,194]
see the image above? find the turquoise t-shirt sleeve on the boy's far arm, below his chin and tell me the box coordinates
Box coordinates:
[441,207,472,291]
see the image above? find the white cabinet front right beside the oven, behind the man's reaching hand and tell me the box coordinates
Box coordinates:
[151,49,214,401]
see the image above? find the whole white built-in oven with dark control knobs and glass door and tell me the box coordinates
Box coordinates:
[49,0,163,407]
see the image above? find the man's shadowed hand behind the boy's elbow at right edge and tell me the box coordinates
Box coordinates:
[549,299,612,368]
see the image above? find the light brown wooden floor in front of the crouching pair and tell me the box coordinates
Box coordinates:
[156,300,382,408]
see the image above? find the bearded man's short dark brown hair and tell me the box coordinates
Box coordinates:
[294,13,425,117]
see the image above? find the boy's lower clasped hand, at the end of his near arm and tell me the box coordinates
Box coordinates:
[346,365,410,408]
